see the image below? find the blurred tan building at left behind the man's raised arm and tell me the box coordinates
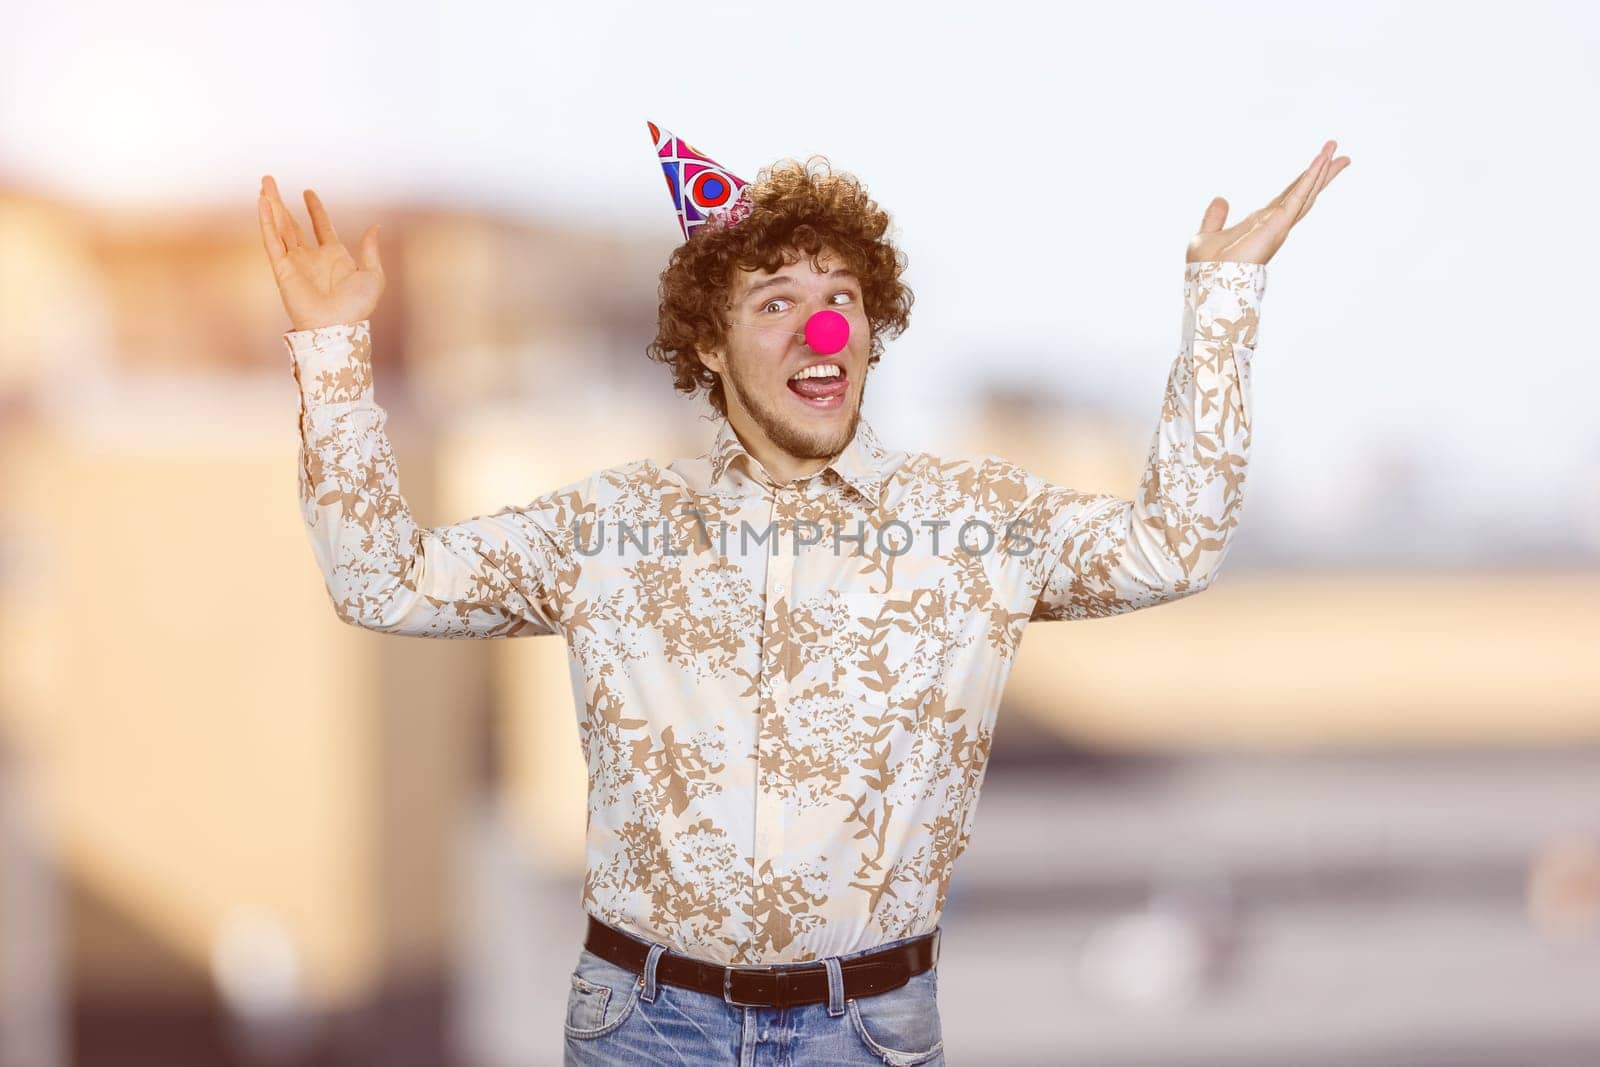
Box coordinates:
[0,185,709,1064]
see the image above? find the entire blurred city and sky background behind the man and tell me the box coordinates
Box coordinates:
[0,3,1600,1067]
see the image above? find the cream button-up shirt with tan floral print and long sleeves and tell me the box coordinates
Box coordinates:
[285,262,1266,965]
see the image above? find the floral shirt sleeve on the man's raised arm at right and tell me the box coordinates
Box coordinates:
[1029,261,1267,621]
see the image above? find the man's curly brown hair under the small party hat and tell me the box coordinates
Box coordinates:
[648,155,912,418]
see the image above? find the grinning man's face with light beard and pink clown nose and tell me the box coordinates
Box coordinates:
[701,246,872,459]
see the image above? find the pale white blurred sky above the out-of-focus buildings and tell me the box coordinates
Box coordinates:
[0,0,1600,559]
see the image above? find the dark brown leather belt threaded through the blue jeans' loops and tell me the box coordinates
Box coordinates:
[584,915,941,1008]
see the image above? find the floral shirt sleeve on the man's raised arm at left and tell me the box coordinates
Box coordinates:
[283,318,573,638]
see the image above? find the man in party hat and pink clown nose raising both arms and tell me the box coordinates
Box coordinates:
[259,123,1349,1064]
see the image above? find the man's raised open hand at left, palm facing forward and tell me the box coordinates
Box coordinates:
[256,174,384,330]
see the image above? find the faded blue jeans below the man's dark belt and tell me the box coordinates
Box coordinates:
[565,937,944,1067]
